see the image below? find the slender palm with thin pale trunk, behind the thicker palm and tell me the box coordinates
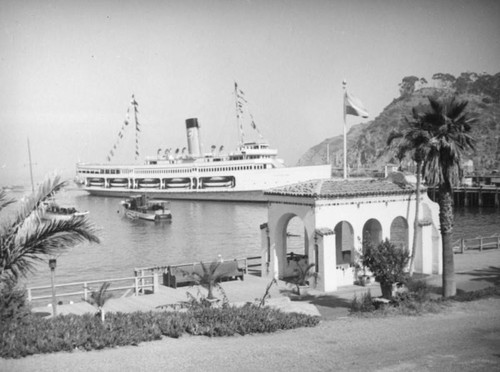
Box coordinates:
[387,108,431,276]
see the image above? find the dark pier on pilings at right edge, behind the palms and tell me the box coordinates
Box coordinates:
[428,186,500,208]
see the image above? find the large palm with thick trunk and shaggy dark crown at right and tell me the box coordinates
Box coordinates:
[422,97,476,297]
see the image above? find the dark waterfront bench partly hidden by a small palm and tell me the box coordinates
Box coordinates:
[163,260,246,288]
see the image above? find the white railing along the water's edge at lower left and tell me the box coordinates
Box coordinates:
[26,274,159,302]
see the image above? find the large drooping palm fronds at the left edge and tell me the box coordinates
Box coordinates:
[0,176,99,282]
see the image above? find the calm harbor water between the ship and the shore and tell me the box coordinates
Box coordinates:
[2,190,500,286]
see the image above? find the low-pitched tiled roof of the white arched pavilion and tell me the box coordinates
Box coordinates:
[264,178,415,199]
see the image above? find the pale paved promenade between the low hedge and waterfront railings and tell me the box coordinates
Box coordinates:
[33,250,500,319]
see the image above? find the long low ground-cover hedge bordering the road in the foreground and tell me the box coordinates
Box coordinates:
[0,304,319,358]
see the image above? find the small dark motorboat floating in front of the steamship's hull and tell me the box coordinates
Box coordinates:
[121,195,172,221]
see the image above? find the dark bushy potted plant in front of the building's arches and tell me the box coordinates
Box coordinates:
[362,239,410,300]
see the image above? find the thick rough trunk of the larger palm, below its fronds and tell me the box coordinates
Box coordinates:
[438,185,457,297]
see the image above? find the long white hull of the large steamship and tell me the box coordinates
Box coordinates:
[78,161,331,202]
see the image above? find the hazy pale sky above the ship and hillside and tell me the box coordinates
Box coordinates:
[0,0,500,185]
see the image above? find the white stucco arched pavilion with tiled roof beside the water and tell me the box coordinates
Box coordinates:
[261,173,442,292]
